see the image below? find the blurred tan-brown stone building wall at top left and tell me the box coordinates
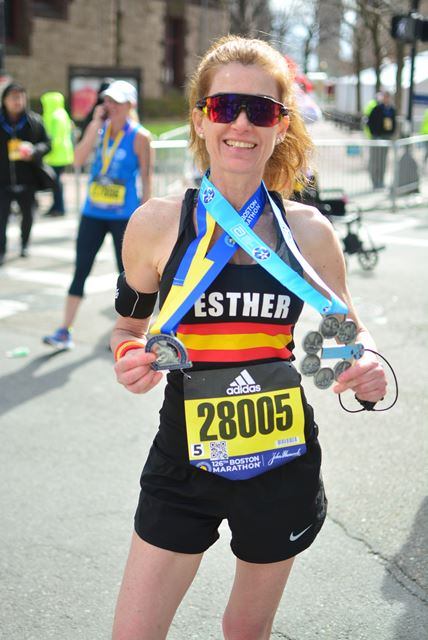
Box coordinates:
[5,0,228,99]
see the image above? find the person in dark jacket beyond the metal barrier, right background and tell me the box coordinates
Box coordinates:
[367,91,396,189]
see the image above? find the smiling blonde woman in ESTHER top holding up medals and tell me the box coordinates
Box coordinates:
[111,36,385,640]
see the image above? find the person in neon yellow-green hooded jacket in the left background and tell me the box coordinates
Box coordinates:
[40,91,74,217]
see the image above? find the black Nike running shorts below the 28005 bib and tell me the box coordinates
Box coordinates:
[135,439,327,563]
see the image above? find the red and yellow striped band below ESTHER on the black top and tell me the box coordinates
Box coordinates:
[177,322,293,362]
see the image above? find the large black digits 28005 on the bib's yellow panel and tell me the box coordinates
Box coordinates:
[197,393,293,442]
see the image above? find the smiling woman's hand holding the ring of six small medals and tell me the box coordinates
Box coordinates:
[333,352,387,402]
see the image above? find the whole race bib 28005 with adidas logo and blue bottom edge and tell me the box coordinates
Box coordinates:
[184,362,306,480]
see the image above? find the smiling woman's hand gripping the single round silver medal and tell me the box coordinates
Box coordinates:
[114,349,163,393]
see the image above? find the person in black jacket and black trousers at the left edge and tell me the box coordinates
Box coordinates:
[0,82,51,266]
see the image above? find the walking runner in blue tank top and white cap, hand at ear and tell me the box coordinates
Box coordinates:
[43,80,153,350]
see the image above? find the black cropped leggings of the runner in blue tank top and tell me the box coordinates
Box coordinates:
[68,216,128,298]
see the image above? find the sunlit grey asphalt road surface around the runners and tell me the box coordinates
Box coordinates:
[0,188,428,640]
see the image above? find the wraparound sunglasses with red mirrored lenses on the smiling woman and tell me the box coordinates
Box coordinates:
[196,93,288,127]
